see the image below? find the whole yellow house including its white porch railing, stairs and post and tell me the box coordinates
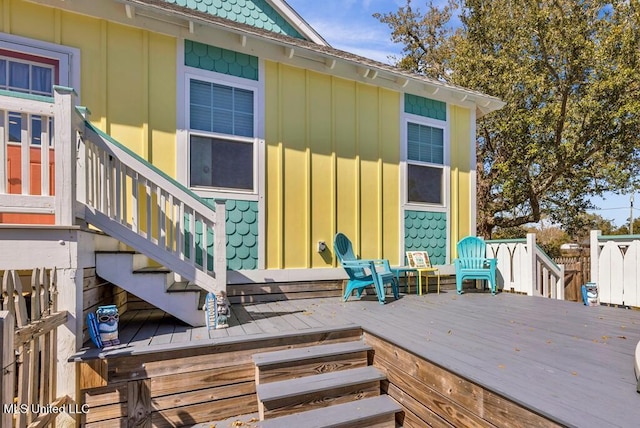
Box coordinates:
[0,0,504,418]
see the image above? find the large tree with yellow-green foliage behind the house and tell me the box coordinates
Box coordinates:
[379,0,640,236]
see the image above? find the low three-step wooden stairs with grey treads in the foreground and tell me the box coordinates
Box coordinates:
[253,341,401,428]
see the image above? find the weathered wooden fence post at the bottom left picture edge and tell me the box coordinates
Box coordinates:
[0,311,16,427]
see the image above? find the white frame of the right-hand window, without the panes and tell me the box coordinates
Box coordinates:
[400,113,451,212]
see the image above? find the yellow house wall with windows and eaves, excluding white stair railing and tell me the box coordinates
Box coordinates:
[0,0,503,282]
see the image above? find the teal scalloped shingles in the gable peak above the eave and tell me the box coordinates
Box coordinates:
[164,0,304,39]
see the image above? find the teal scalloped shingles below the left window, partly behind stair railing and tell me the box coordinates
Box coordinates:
[185,198,258,270]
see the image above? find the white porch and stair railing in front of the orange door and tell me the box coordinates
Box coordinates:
[0,87,226,292]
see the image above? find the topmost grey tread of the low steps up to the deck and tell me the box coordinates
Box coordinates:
[253,341,373,367]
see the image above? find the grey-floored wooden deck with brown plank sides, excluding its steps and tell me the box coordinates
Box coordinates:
[76,290,640,427]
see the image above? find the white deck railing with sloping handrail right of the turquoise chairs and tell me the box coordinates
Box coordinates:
[487,233,564,299]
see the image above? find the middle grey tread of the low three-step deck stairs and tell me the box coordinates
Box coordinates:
[256,366,386,403]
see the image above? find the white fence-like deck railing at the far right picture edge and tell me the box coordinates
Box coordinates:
[590,230,640,307]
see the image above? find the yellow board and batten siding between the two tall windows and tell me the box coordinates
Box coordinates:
[265,61,400,269]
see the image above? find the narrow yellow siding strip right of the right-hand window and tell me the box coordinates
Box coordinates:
[449,105,476,260]
